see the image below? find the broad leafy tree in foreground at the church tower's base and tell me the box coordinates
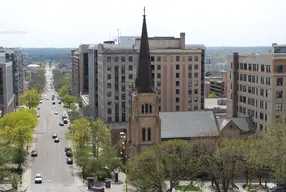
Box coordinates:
[126,140,199,192]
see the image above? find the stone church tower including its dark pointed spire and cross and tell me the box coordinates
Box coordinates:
[127,8,161,158]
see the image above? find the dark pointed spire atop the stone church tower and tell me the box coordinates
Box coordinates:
[135,7,154,93]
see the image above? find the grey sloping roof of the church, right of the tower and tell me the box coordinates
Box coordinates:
[159,110,219,139]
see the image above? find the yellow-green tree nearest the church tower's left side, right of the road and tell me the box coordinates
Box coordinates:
[90,118,110,157]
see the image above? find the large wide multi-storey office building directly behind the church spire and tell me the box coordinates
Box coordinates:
[89,33,205,122]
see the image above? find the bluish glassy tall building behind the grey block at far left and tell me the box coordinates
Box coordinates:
[0,48,25,106]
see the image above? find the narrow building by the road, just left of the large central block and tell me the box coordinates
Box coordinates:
[71,44,89,98]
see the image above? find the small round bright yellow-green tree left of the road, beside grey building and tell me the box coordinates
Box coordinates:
[20,89,41,109]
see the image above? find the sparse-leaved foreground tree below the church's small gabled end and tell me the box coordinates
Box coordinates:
[195,137,243,192]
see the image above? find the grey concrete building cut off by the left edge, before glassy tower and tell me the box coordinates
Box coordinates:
[0,53,15,116]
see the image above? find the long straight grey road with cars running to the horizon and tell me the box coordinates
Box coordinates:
[29,65,84,192]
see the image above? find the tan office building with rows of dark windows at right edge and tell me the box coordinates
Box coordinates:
[227,44,286,130]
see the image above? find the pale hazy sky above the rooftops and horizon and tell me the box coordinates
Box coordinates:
[0,0,286,48]
